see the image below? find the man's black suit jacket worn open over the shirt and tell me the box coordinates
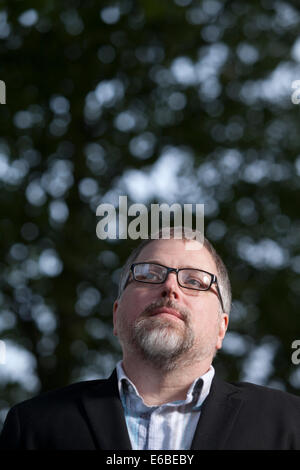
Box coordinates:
[0,370,300,450]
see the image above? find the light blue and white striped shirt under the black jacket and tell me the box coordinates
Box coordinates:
[117,361,215,450]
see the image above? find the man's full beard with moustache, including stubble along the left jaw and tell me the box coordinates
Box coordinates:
[118,299,203,372]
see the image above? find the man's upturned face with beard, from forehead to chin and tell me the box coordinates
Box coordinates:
[114,239,228,370]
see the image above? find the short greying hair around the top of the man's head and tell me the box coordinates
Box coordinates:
[118,227,232,315]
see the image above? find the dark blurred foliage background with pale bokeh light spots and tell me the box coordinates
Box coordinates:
[0,0,300,430]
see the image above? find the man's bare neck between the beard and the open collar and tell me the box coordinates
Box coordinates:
[122,356,212,406]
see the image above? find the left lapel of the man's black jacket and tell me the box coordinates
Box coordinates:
[82,370,131,450]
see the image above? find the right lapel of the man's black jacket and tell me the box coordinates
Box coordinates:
[191,377,243,450]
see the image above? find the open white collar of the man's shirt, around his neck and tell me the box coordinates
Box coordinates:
[116,361,215,409]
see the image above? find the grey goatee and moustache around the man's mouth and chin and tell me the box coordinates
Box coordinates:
[131,302,195,371]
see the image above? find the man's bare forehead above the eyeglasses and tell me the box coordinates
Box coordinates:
[134,239,217,274]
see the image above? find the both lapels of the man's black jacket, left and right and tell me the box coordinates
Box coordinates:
[81,369,243,450]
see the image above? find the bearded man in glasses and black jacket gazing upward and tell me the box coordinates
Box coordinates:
[0,232,300,450]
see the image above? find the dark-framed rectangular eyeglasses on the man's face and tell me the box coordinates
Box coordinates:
[125,263,224,312]
